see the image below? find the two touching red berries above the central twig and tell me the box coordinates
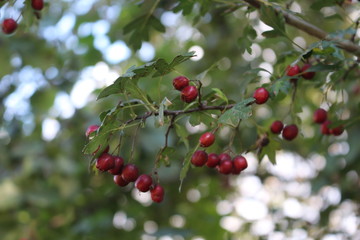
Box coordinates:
[173,76,199,103]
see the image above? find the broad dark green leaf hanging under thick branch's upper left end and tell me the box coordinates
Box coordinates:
[260,4,285,36]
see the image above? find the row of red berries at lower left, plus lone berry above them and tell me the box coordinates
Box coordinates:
[85,125,164,203]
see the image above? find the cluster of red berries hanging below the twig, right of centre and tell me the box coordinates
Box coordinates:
[191,132,247,175]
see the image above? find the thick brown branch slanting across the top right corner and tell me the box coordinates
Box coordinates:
[243,0,360,57]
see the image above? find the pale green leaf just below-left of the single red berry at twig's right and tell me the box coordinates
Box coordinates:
[218,98,255,127]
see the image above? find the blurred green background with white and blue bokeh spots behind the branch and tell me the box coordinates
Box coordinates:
[0,0,360,240]
